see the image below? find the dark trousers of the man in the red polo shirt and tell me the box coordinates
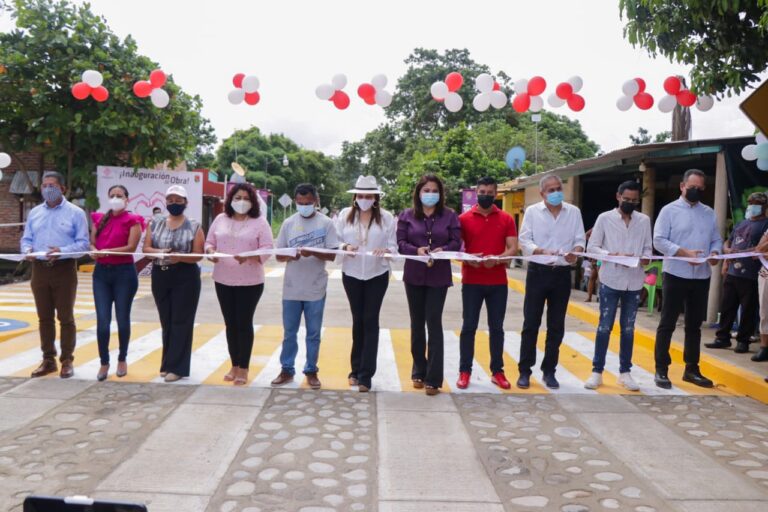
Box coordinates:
[459,284,509,374]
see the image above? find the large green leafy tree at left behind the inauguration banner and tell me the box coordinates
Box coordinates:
[0,0,216,206]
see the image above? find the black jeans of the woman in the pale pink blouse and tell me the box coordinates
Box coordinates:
[216,283,264,370]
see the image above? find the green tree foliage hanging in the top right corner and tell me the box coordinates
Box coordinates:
[619,0,768,96]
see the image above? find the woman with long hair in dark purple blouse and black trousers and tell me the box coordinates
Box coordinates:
[397,174,461,396]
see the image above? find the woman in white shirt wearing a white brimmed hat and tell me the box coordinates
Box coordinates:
[336,176,397,392]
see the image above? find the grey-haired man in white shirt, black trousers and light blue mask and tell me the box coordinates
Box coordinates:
[517,174,586,389]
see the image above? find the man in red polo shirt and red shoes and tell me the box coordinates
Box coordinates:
[456,177,517,389]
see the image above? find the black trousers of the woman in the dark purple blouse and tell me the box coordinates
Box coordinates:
[405,283,448,388]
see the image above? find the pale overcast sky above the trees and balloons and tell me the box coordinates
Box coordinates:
[0,0,753,154]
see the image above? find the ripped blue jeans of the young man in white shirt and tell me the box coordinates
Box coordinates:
[592,284,640,373]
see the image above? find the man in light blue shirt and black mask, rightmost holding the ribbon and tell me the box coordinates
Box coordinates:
[653,169,723,389]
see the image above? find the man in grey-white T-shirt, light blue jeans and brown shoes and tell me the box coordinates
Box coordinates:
[272,183,339,389]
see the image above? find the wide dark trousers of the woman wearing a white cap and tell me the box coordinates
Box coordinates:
[152,263,200,377]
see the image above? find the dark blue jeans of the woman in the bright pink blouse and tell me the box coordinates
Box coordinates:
[93,263,139,364]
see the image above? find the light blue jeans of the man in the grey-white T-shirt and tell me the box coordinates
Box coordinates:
[280,297,325,375]
